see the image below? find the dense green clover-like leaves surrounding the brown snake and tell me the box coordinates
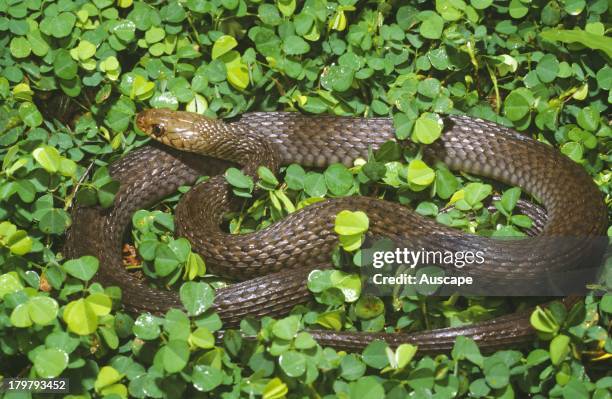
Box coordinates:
[0,0,612,399]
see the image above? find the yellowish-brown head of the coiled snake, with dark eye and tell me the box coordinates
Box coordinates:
[136,109,200,150]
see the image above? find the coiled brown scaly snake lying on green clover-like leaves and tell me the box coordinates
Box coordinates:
[65,109,607,354]
